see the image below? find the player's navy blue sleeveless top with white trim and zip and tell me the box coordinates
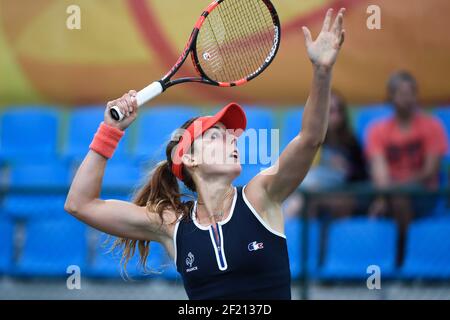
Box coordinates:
[174,186,291,300]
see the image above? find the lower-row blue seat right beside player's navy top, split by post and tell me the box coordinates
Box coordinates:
[284,218,320,279]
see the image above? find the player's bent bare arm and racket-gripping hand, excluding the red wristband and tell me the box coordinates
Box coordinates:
[64,91,172,241]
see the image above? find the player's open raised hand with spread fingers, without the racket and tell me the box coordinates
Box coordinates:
[302,8,345,68]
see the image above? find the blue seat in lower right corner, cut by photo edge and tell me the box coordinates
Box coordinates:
[400,218,450,279]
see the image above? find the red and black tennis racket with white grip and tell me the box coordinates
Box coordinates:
[110,0,281,121]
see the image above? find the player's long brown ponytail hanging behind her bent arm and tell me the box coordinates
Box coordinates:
[110,117,198,275]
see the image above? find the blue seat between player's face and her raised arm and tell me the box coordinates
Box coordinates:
[237,106,281,166]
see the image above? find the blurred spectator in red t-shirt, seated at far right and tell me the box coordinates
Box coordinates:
[366,71,448,262]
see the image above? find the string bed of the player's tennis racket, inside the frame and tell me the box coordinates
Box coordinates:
[196,0,278,82]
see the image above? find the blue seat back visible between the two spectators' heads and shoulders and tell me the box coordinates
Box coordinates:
[354,104,394,145]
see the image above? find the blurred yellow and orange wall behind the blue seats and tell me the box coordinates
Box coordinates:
[0,0,450,106]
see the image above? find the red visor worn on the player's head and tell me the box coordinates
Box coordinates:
[172,103,247,180]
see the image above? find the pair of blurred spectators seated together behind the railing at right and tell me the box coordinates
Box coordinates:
[284,71,448,264]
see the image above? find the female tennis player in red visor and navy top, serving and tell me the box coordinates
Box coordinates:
[65,9,345,299]
